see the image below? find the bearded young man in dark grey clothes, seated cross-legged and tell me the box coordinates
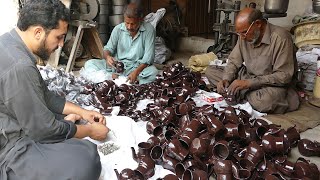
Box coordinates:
[0,0,109,180]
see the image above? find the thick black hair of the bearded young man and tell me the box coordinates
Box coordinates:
[17,0,70,31]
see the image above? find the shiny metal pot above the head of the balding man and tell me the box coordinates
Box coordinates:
[264,0,289,14]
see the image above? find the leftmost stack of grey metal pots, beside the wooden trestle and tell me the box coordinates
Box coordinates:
[96,0,111,45]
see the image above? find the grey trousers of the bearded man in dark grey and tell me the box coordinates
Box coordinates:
[0,138,101,180]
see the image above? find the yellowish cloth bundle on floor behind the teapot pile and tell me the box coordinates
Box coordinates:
[188,52,218,73]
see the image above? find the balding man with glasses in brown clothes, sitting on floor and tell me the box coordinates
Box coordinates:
[206,8,300,113]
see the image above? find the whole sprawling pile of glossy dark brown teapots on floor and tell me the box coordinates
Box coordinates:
[79,63,320,180]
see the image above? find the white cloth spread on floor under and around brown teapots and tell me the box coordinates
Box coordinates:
[87,91,265,180]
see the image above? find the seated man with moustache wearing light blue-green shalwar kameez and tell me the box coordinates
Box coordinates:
[85,3,158,84]
